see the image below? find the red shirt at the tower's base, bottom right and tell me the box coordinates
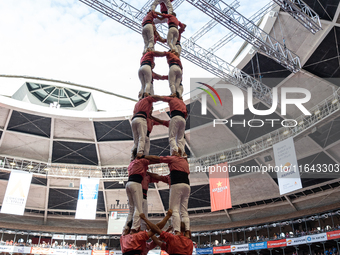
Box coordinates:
[160,231,193,255]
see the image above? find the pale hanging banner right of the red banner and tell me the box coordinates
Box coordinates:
[273,137,302,195]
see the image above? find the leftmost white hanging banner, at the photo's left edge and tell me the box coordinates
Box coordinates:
[1,170,32,215]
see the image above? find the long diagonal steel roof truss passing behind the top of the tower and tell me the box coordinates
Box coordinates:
[79,0,272,105]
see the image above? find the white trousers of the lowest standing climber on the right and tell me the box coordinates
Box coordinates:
[169,183,190,231]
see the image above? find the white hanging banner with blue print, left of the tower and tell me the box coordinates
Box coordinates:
[76,178,99,220]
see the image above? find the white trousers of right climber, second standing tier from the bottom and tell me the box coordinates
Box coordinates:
[169,116,185,154]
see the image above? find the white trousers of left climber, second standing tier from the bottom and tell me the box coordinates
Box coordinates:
[131,117,148,154]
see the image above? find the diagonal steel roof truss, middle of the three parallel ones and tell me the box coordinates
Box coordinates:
[187,0,301,73]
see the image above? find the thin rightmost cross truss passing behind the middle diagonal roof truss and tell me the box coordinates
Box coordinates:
[209,2,276,53]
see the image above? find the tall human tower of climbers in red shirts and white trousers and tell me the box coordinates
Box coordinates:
[120,0,193,255]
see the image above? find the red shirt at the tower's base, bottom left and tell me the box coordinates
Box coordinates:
[120,231,149,253]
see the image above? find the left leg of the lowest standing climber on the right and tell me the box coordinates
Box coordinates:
[169,184,181,231]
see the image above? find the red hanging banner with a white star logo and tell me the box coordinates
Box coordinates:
[209,162,232,212]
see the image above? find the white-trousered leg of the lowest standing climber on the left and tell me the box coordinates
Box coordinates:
[128,182,143,230]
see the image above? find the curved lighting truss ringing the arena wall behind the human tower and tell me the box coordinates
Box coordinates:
[0,88,340,178]
